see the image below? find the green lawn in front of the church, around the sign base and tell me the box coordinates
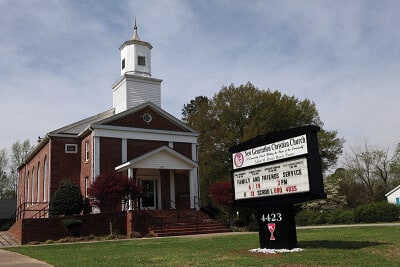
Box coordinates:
[3,226,400,267]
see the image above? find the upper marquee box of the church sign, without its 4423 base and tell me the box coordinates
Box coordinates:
[230,126,325,204]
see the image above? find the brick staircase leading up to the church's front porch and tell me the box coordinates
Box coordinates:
[144,209,231,236]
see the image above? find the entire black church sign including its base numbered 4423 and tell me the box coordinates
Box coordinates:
[230,126,326,249]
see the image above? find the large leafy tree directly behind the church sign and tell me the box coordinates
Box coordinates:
[182,82,344,198]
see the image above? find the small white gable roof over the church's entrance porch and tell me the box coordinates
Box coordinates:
[115,146,197,171]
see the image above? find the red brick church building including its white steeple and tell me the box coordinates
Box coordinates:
[17,23,199,218]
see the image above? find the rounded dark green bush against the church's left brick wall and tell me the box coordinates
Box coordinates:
[50,179,83,216]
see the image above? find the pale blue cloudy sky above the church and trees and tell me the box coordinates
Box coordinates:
[0,0,400,168]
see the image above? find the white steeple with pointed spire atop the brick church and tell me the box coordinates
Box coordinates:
[112,18,162,113]
